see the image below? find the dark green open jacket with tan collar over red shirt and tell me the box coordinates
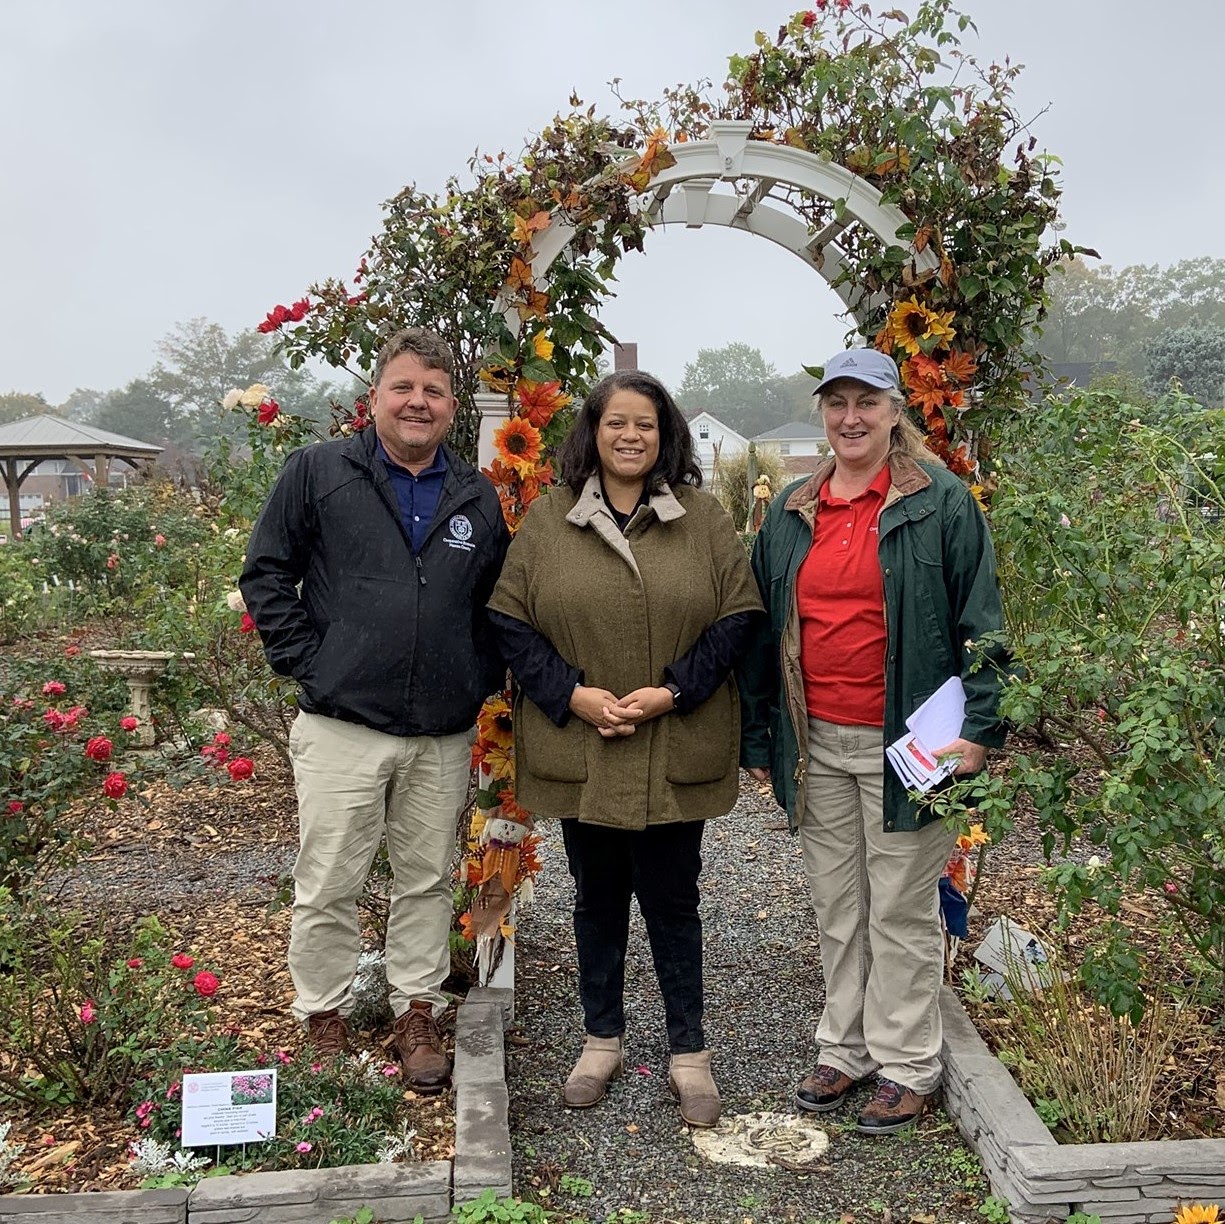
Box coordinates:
[739,457,1008,832]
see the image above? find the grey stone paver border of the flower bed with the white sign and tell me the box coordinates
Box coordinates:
[0,989,515,1224]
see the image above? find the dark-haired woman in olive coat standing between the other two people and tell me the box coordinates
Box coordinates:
[489,370,761,1126]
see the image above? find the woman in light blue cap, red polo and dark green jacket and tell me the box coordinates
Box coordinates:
[741,349,1006,1135]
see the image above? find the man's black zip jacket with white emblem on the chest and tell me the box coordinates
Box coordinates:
[239,428,510,735]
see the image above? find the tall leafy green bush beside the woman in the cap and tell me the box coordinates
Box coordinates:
[935,392,1225,1022]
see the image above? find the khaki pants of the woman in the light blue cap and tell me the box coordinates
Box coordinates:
[799,718,957,1094]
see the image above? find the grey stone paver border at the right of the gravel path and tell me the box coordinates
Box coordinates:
[940,986,1225,1224]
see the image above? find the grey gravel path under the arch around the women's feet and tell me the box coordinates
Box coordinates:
[508,777,987,1224]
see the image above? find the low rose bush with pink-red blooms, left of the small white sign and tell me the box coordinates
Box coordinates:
[0,888,216,1108]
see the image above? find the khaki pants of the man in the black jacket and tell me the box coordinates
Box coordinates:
[289,712,472,1021]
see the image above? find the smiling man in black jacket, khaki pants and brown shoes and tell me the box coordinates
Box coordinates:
[239,328,510,1093]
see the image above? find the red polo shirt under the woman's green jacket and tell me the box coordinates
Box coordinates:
[795,464,889,727]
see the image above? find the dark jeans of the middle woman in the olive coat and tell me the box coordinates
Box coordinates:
[561,820,706,1054]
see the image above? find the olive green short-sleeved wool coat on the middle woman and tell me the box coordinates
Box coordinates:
[489,477,762,829]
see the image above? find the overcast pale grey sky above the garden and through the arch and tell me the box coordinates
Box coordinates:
[0,0,1225,404]
